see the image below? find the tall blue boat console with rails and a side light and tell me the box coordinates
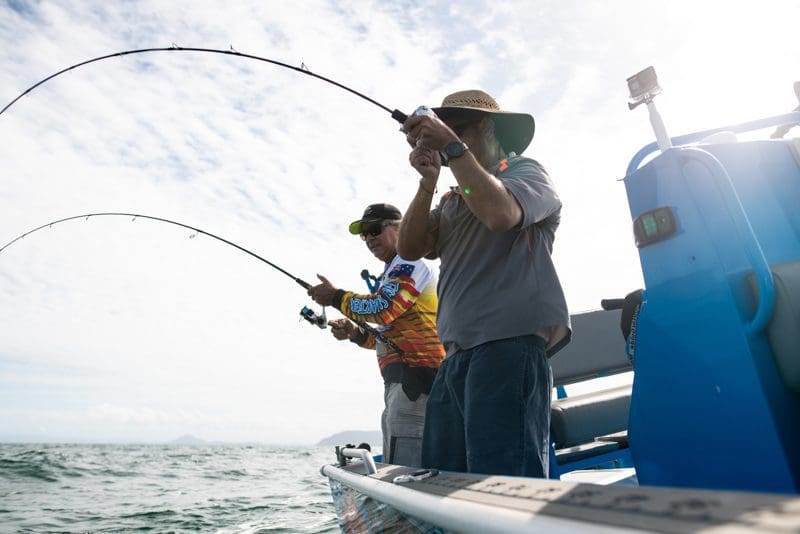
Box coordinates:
[625,113,800,493]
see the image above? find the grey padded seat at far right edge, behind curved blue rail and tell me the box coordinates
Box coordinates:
[748,261,800,393]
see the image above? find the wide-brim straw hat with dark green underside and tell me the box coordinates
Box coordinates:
[433,89,536,154]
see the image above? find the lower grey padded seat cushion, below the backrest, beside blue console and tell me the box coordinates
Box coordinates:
[550,385,631,452]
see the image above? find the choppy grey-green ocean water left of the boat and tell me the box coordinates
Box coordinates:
[0,444,340,533]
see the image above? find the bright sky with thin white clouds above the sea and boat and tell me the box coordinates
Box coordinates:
[0,0,800,443]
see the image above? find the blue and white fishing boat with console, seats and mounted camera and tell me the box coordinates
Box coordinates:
[321,67,800,532]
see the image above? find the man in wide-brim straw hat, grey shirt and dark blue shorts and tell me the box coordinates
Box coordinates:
[398,90,570,477]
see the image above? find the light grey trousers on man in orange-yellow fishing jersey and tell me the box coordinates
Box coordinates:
[381,383,428,467]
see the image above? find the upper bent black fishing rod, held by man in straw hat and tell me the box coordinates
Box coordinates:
[0,43,408,124]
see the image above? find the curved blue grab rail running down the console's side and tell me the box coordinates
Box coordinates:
[675,149,772,334]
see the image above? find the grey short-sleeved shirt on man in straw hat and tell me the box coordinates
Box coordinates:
[429,154,570,356]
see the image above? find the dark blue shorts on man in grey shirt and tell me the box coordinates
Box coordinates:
[422,335,553,478]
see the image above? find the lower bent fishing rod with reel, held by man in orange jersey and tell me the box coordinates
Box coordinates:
[0,211,403,354]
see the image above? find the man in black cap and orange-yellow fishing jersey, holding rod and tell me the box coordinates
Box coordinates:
[308,204,444,467]
